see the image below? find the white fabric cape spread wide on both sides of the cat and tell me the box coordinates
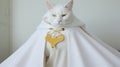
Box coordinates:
[0,18,120,67]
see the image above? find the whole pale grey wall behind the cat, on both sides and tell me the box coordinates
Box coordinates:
[11,0,120,51]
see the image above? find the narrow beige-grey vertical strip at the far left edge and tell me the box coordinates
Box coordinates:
[0,0,10,62]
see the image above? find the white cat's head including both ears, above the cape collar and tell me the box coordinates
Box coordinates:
[43,0,73,27]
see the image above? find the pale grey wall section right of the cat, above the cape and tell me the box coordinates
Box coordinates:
[76,0,120,49]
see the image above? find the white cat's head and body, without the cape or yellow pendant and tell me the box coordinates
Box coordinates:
[43,0,74,67]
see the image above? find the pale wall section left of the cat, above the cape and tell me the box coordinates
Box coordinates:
[11,0,46,51]
